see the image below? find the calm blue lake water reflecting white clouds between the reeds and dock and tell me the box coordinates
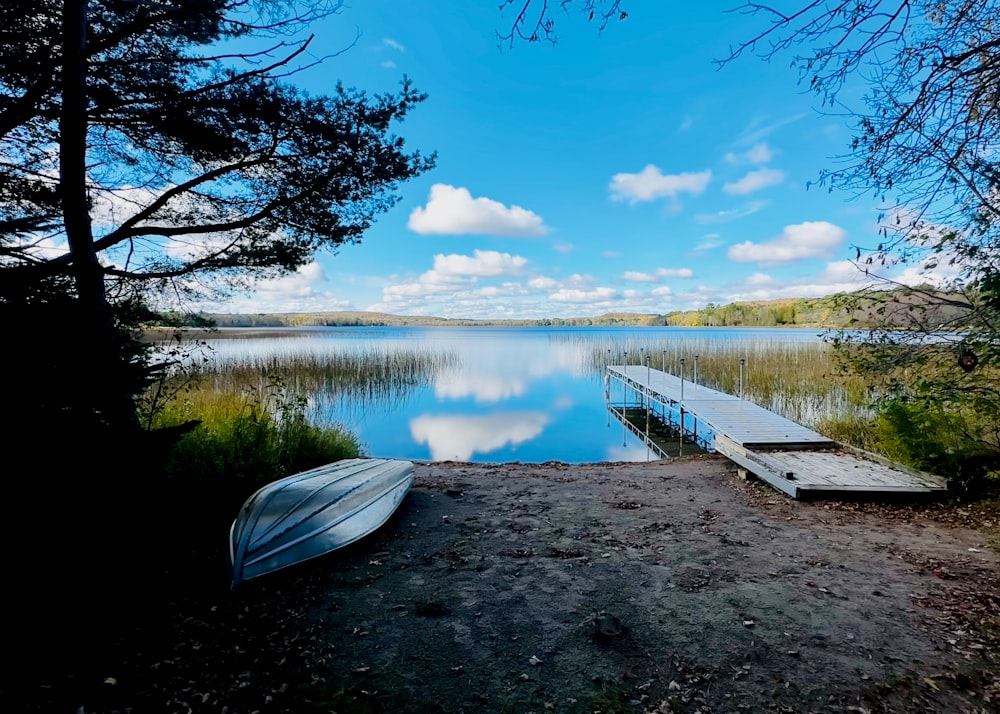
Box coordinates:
[199,327,820,463]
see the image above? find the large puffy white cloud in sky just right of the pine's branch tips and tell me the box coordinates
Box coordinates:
[406,183,549,238]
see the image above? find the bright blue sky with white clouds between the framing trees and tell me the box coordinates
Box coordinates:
[204,0,940,318]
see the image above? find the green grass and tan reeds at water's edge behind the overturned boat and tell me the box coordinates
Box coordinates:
[143,345,453,495]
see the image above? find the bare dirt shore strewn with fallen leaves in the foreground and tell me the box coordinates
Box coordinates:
[33,457,1000,714]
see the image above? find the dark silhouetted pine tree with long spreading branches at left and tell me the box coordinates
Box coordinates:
[0,0,433,454]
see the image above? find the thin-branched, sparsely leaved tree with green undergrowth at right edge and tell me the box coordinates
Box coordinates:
[724,0,1000,478]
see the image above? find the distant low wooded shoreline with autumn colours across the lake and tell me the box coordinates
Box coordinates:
[159,290,961,329]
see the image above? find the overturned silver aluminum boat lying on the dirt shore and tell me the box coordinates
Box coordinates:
[229,459,413,587]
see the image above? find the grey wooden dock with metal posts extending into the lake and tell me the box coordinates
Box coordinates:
[607,365,947,498]
